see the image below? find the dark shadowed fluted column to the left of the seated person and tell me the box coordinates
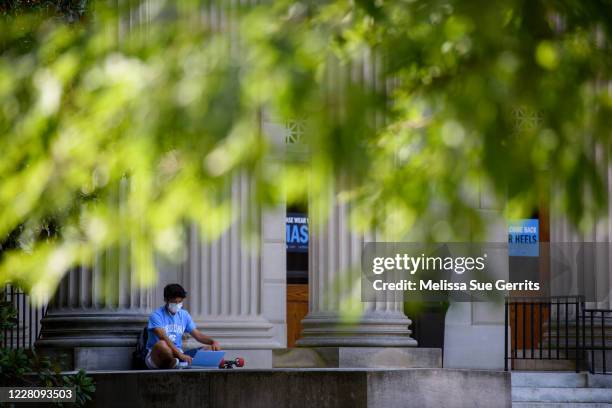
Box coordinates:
[35,180,152,369]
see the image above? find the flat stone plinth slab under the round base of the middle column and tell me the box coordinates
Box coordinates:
[272,347,442,368]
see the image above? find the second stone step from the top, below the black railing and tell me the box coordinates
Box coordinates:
[512,387,612,406]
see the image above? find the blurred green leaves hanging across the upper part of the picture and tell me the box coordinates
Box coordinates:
[0,0,612,302]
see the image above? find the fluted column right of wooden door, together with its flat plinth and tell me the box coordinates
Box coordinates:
[274,194,441,368]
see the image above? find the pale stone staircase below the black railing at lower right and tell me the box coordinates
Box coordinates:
[512,371,612,408]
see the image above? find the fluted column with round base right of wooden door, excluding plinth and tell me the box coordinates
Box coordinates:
[297,194,417,347]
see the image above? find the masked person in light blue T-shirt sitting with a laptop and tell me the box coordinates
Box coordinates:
[145,283,221,369]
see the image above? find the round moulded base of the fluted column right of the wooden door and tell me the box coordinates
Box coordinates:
[297,311,417,347]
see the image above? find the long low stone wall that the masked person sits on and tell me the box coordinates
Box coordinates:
[82,368,511,408]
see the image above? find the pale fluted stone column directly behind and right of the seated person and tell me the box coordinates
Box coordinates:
[183,175,286,368]
